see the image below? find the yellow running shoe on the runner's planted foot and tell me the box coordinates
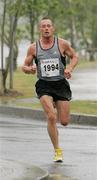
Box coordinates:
[54,148,63,162]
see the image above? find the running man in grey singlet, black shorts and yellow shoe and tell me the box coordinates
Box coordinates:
[22,18,78,162]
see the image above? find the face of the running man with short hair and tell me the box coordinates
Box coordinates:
[40,19,54,38]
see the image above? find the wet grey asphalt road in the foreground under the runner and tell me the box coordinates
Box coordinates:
[0,114,97,180]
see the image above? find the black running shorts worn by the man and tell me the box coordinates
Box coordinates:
[35,79,72,101]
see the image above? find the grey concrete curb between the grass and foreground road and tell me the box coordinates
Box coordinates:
[0,106,97,126]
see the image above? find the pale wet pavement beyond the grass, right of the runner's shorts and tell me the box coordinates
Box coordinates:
[70,67,97,100]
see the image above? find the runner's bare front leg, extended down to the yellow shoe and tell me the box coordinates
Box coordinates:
[40,95,59,149]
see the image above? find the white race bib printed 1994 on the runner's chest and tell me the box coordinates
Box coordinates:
[40,58,59,77]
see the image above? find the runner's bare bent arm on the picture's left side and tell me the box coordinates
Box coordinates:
[22,43,36,74]
